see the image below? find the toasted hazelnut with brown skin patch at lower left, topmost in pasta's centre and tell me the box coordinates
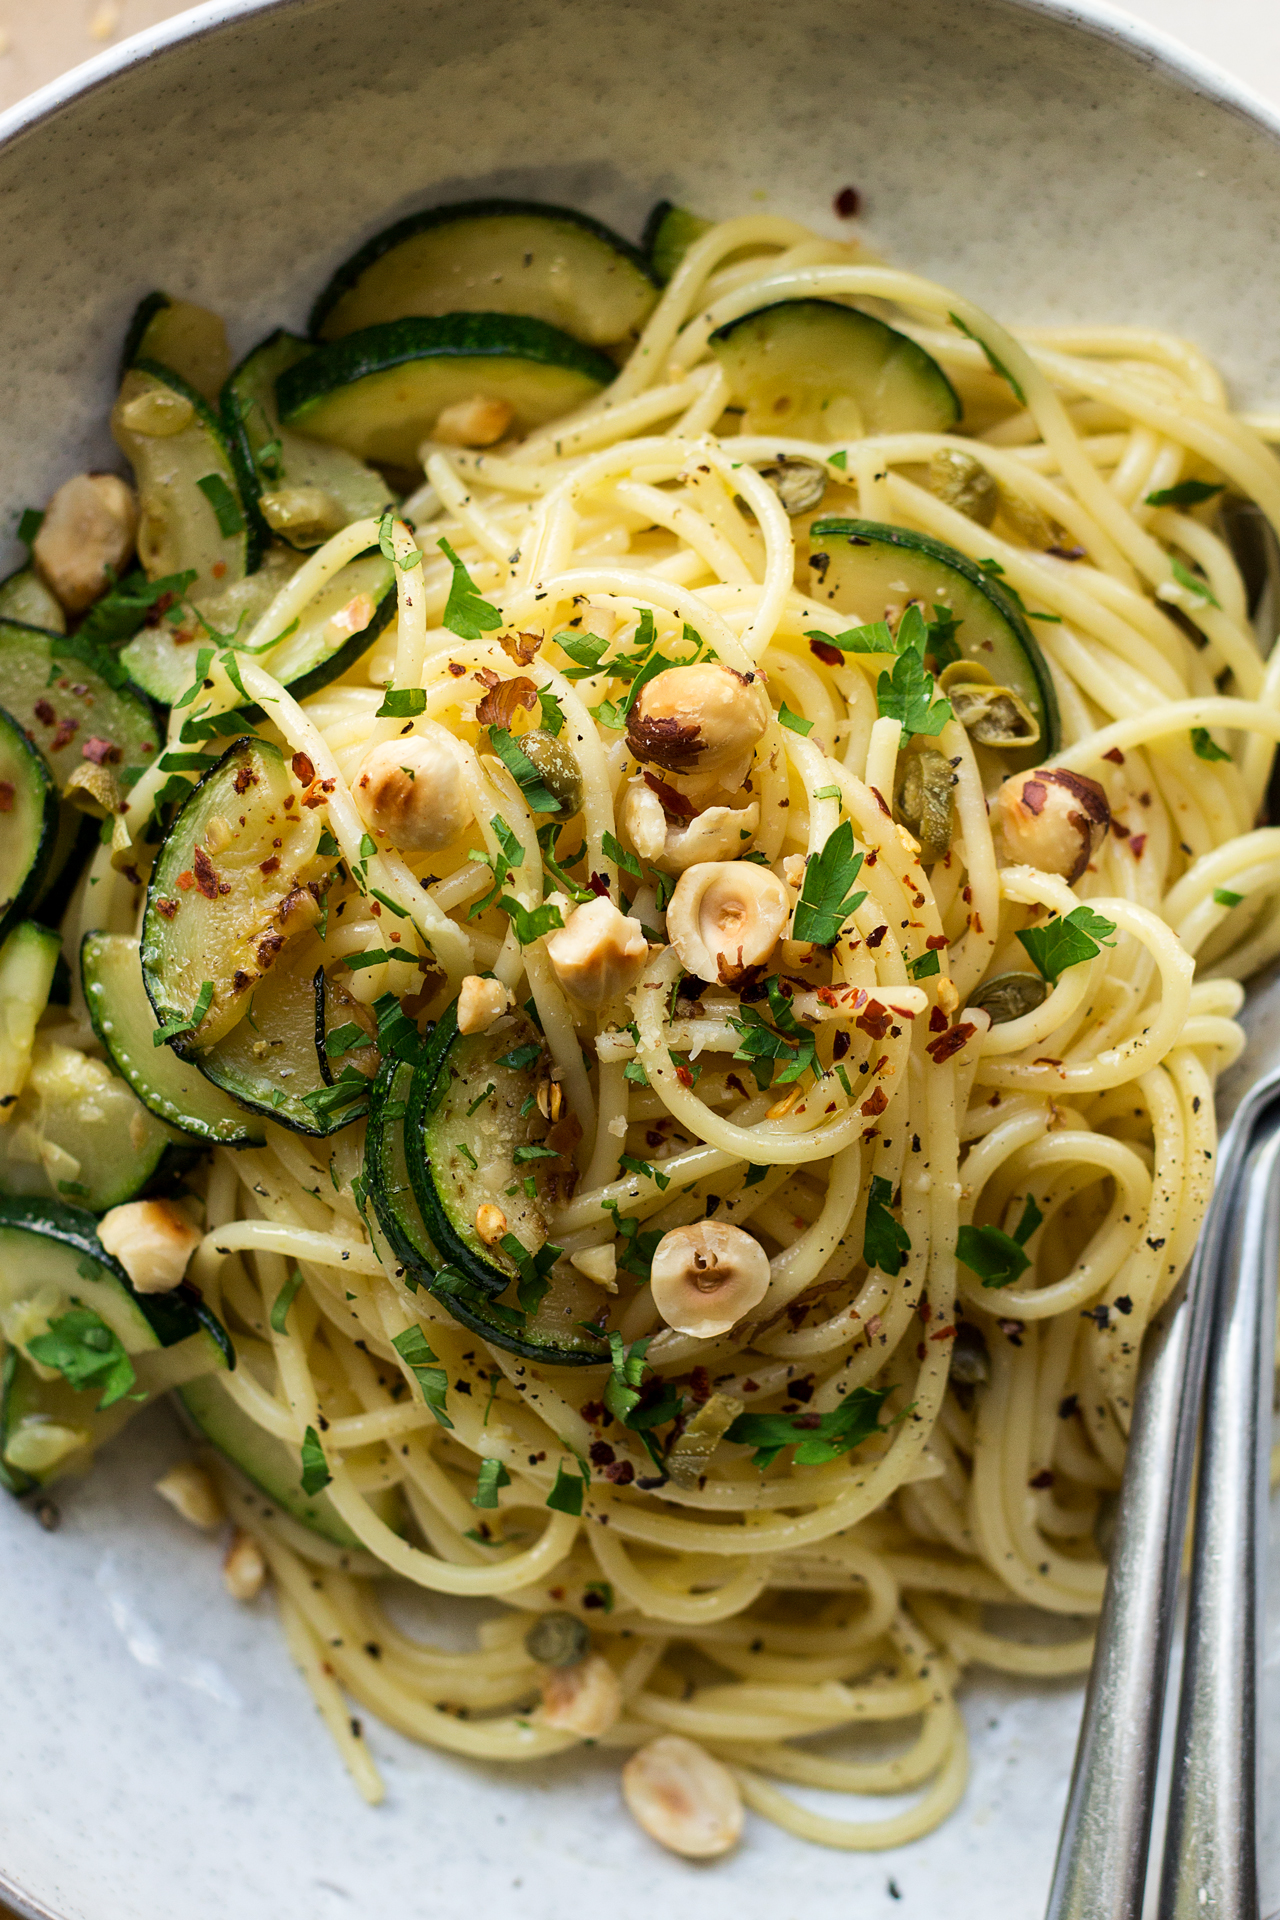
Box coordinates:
[628,660,770,787]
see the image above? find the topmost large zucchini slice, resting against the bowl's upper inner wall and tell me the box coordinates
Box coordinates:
[311,200,658,348]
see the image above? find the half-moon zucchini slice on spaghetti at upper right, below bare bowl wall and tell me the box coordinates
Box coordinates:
[710,300,960,444]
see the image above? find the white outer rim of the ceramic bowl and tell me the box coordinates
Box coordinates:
[0,0,1280,1920]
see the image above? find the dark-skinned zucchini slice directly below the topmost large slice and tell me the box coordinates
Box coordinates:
[276,313,614,470]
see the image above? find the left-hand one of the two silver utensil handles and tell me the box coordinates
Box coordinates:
[1046,970,1280,1920]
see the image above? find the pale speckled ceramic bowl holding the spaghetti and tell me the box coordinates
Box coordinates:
[0,0,1280,1920]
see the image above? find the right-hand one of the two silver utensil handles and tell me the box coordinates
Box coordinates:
[1159,1114,1280,1920]
